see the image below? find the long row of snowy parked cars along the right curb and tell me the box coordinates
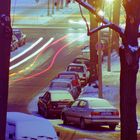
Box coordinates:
[38,57,119,130]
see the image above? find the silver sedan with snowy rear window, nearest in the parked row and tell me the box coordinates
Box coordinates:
[61,97,120,130]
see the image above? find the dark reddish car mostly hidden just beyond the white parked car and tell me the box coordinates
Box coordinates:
[73,57,90,70]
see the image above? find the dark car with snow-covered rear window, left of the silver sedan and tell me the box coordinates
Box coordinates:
[38,90,74,117]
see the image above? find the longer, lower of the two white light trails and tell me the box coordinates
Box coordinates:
[10,38,54,70]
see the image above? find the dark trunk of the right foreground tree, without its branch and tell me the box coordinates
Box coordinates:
[120,8,139,140]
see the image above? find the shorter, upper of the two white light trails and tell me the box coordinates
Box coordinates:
[10,37,43,62]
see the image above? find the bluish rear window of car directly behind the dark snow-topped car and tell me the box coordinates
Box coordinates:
[50,82,70,88]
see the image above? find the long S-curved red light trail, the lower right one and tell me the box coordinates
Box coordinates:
[13,35,84,81]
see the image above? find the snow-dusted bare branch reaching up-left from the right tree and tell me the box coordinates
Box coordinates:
[76,0,124,37]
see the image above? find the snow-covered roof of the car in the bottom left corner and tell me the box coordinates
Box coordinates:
[7,112,57,139]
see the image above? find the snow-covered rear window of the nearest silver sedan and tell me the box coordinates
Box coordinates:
[88,100,112,108]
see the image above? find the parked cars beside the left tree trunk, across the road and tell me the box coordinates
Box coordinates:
[11,28,26,51]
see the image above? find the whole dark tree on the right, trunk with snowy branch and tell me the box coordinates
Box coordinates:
[76,0,140,140]
